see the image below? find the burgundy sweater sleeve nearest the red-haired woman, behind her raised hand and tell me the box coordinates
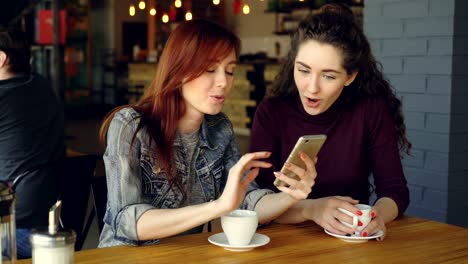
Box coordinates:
[249,100,281,192]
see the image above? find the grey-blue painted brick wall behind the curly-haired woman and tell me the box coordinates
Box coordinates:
[364,0,468,227]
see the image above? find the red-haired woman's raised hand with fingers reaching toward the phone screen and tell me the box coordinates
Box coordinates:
[217,151,271,213]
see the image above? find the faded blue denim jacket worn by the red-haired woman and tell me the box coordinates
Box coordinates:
[99,108,272,247]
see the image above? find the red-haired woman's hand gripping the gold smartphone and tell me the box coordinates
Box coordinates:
[274,152,317,201]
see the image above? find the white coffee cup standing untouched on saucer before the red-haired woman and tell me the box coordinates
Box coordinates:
[221,210,258,246]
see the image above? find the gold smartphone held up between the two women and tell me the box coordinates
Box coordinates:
[273,135,327,187]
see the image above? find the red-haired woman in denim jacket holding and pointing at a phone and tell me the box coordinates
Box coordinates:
[99,20,315,247]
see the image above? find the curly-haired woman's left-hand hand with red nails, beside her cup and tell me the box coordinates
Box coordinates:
[303,196,359,235]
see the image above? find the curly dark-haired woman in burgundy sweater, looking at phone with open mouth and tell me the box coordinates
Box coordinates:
[250,4,411,239]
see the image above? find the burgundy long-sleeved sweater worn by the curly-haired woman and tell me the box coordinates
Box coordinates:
[250,95,409,215]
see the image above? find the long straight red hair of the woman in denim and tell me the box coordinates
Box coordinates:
[99,19,240,190]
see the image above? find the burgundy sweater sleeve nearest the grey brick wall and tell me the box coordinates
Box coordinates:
[366,99,409,216]
